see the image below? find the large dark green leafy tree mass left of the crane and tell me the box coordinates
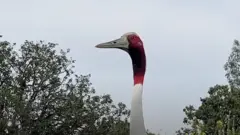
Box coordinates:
[0,41,130,135]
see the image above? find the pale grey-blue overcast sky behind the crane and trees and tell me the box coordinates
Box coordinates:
[0,0,240,134]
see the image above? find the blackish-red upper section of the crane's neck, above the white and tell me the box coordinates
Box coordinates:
[129,48,146,85]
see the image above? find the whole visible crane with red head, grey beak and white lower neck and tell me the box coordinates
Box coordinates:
[96,32,146,135]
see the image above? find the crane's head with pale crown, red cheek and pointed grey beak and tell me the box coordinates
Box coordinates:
[96,32,143,52]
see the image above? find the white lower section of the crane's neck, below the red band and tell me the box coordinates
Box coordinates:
[130,84,146,135]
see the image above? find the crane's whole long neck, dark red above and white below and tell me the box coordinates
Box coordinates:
[128,43,146,135]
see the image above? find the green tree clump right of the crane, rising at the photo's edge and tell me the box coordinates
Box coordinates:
[177,40,240,135]
